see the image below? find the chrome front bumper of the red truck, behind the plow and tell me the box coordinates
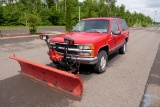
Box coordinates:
[68,57,98,65]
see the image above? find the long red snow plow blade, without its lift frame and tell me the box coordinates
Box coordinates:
[10,56,83,100]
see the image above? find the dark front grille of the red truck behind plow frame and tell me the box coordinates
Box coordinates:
[55,43,78,55]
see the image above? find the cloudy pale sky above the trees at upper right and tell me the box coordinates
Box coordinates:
[79,0,160,22]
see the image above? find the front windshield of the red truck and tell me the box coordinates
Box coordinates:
[72,20,109,33]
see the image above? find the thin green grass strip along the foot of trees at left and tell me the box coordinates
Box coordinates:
[0,26,64,30]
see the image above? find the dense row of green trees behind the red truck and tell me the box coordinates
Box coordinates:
[0,0,152,29]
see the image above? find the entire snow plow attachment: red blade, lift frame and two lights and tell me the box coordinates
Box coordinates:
[10,35,83,100]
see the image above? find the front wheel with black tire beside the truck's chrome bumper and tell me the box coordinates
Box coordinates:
[94,50,108,74]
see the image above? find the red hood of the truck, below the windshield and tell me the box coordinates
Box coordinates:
[50,32,108,44]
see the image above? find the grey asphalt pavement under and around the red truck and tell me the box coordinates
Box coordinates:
[0,27,160,107]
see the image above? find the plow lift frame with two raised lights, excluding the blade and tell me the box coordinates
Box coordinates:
[40,35,80,73]
